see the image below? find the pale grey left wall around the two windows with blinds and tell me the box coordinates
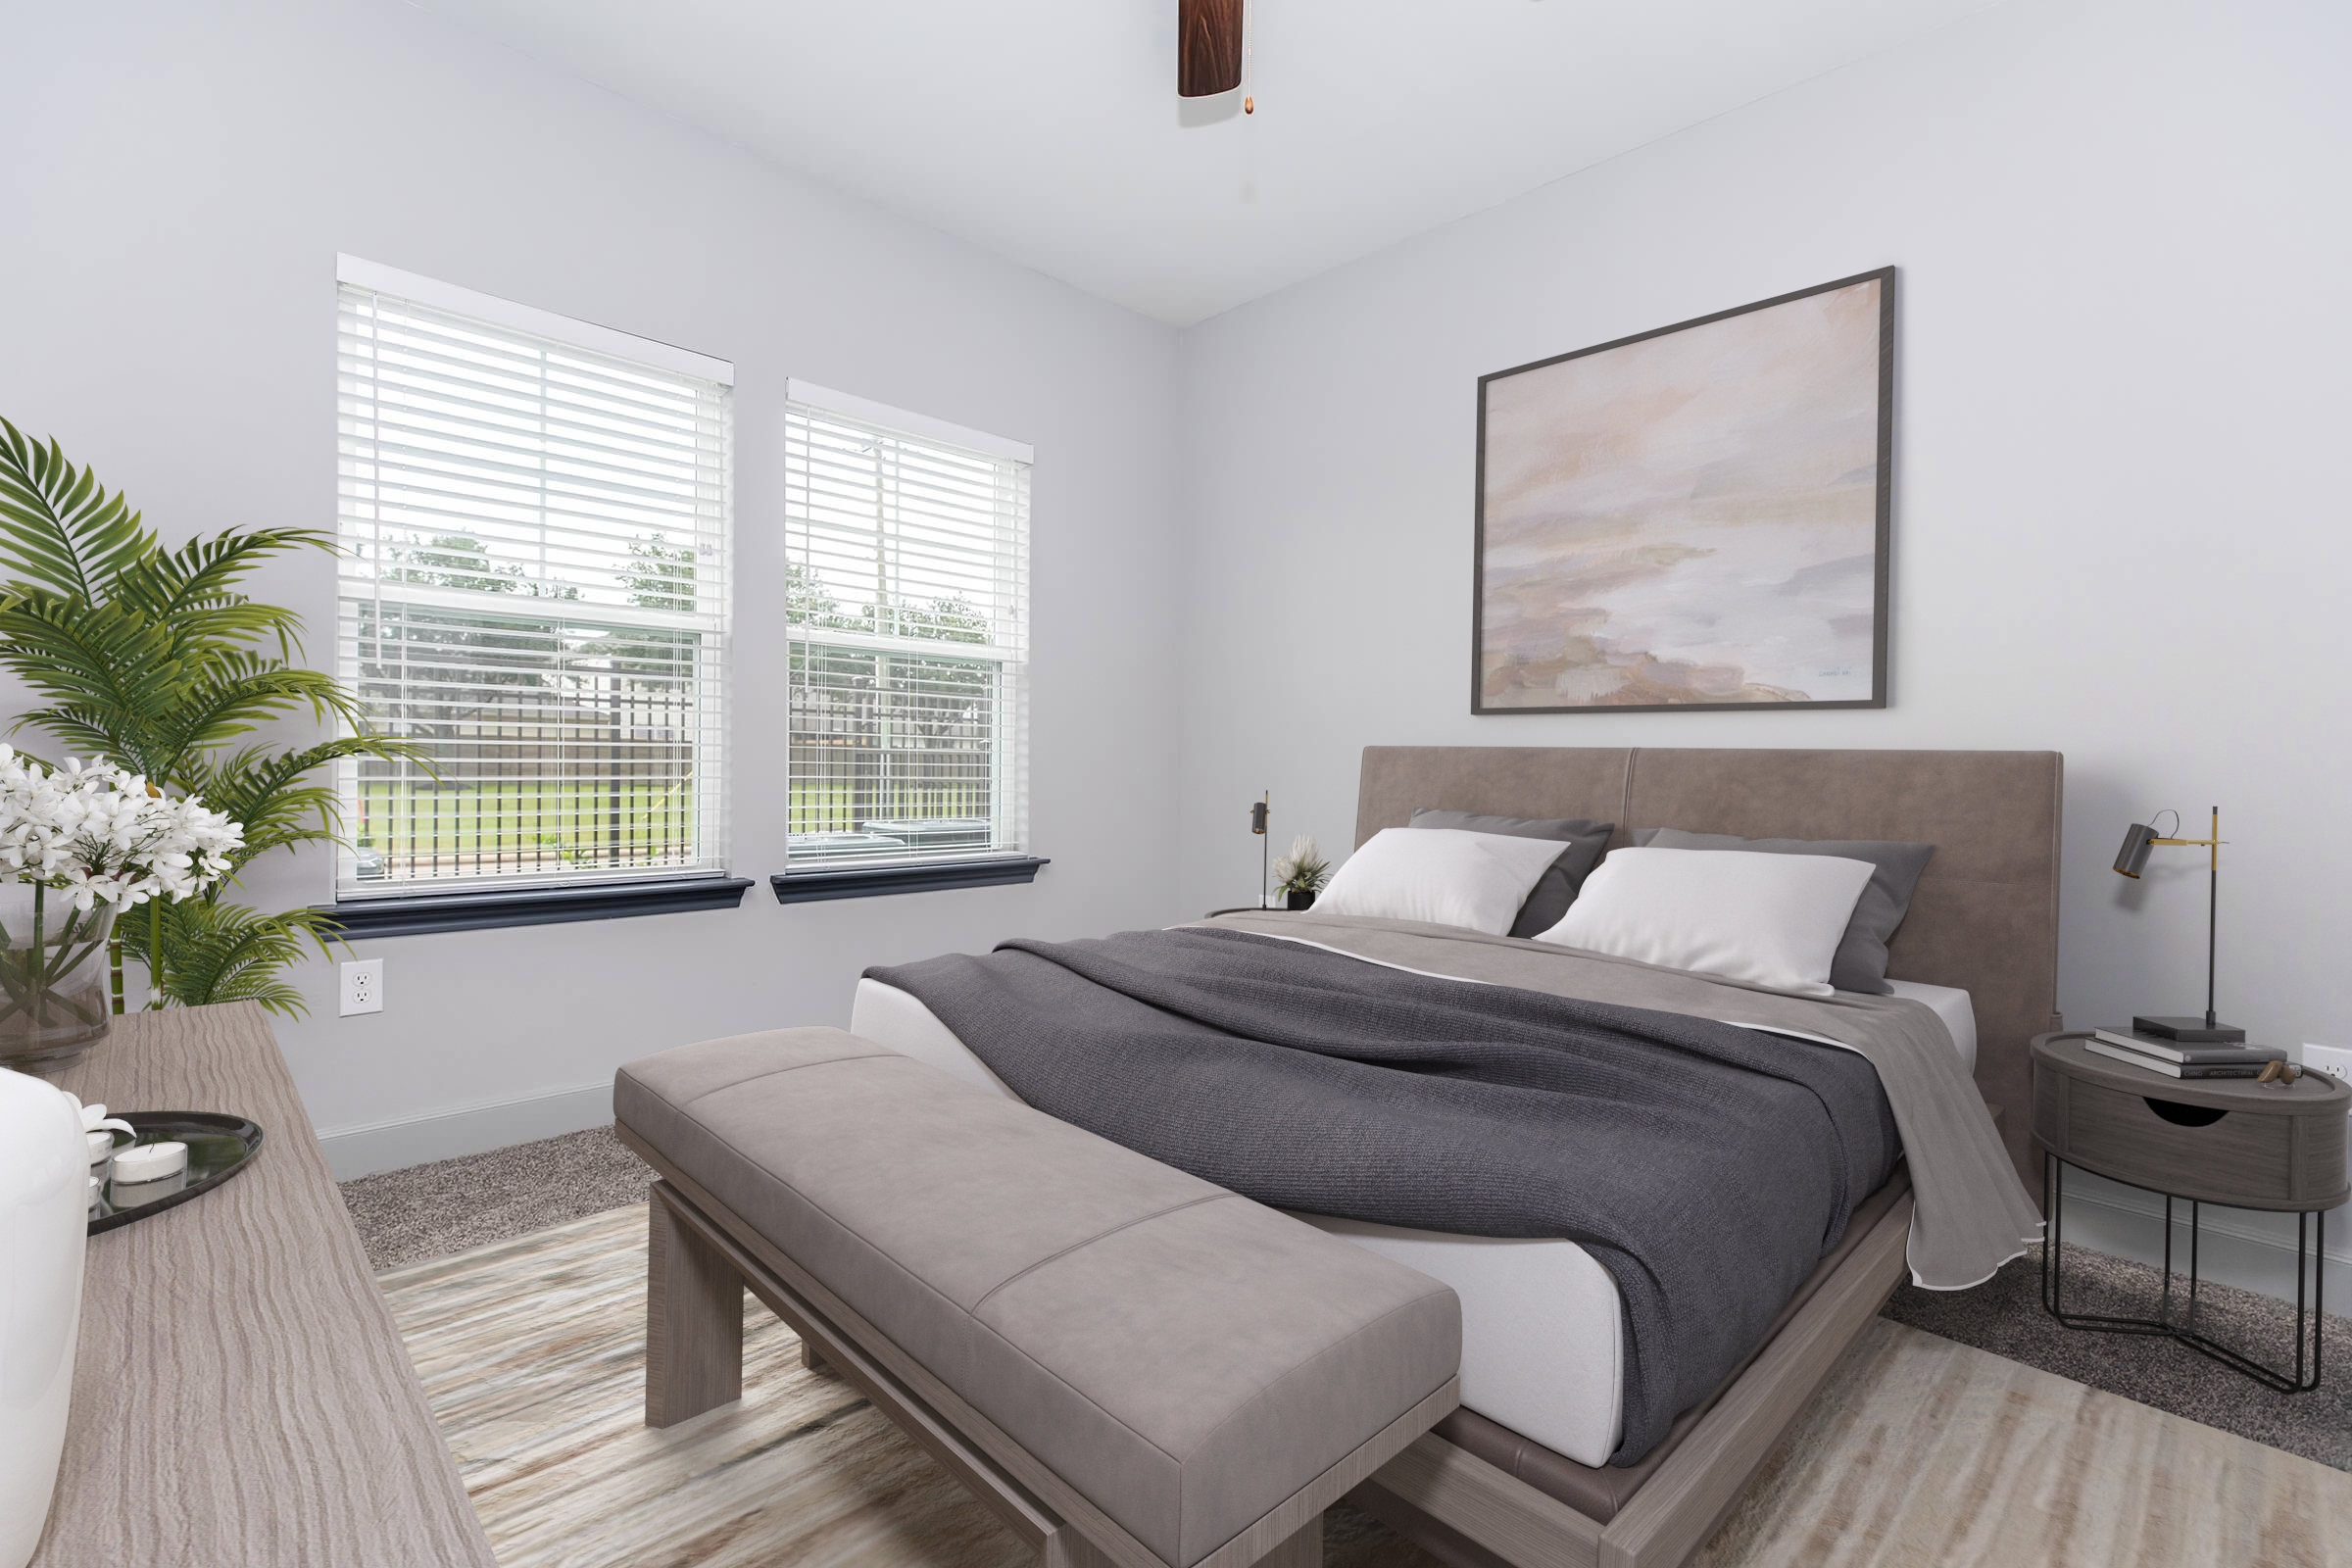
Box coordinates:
[0,0,1176,1168]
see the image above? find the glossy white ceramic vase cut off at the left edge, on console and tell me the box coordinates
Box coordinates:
[0,1069,89,1568]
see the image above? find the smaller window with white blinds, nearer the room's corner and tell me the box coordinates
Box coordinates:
[783,381,1030,872]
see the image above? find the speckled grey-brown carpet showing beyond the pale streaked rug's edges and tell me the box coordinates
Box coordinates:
[343,1126,2352,1469]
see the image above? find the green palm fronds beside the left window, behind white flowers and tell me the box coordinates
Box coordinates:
[0,418,414,1013]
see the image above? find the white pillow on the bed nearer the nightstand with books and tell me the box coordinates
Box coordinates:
[1536,849,1872,997]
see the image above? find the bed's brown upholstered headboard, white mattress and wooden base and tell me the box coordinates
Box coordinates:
[852,748,2060,1566]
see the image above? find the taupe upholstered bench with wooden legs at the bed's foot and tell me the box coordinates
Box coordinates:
[613,1030,1460,1568]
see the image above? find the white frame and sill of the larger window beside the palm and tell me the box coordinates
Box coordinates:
[316,254,751,936]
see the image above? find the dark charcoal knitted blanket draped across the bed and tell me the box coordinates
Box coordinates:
[870,917,2033,1464]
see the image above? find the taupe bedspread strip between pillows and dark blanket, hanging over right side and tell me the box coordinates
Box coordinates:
[1200,909,2041,1291]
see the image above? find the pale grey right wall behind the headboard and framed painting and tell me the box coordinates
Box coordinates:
[1181,0,2352,1298]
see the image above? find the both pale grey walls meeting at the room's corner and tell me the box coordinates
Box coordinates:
[0,0,2352,1316]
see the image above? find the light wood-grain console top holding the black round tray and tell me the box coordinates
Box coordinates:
[33,1002,494,1568]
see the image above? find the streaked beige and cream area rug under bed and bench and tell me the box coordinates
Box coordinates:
[378,1206,2352,1568]
